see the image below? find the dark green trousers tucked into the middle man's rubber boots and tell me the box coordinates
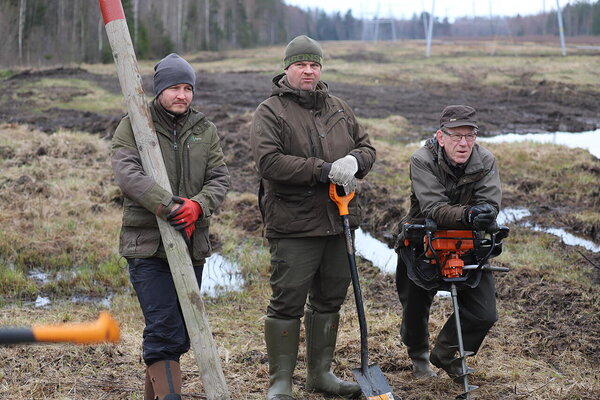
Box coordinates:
[267,235,351,319]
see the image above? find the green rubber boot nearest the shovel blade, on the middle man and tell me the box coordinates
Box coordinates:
[304,310,361,398]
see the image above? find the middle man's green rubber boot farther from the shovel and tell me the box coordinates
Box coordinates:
[265,317,300,400]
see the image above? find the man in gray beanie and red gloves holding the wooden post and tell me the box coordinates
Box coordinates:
[112,54,229,400]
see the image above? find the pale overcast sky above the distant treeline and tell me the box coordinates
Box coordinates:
[284,0,568,19]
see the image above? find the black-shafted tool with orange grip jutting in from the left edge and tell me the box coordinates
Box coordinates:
[0,311,121,344]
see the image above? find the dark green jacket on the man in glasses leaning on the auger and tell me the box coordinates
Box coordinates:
[402,138,502,234]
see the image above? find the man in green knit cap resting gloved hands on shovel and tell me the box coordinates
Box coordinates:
[251,36,375,400]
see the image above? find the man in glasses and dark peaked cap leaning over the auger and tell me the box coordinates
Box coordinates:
[396,105,502,391]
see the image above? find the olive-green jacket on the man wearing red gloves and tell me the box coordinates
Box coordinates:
[112,102,229,264]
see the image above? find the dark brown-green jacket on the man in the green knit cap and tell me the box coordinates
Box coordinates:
[251,74,375,238]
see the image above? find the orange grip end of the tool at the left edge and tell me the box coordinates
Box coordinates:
[31,311,121,344]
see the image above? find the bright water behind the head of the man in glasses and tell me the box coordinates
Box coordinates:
[477,129,600,158]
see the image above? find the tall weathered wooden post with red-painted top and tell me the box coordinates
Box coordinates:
[98,0,231,400]
